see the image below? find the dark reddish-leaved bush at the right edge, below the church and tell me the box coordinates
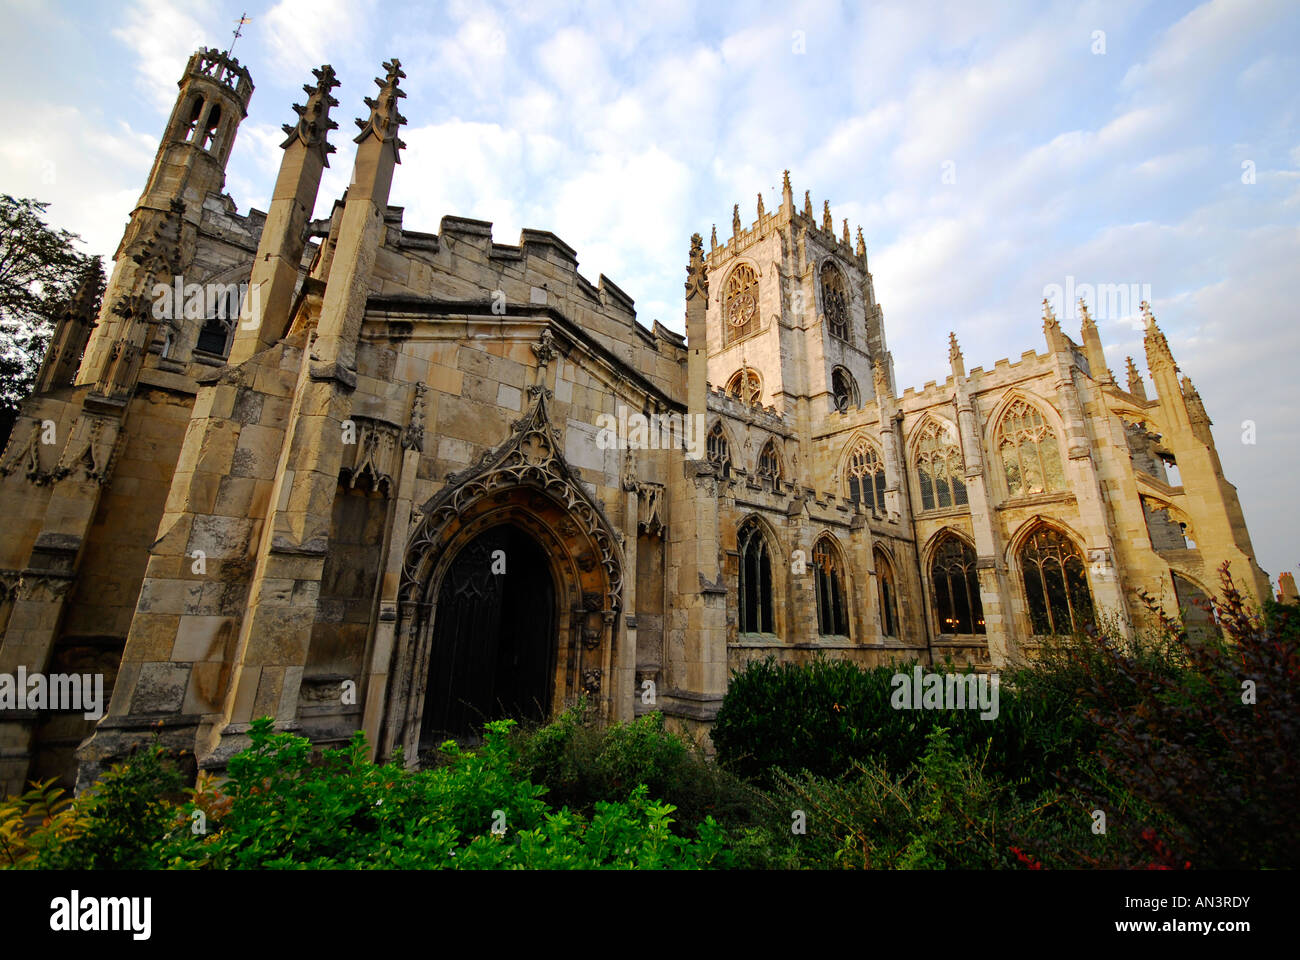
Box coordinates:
[1069,563,1300,869]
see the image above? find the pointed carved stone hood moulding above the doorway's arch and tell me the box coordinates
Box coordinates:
[400,390,623,610]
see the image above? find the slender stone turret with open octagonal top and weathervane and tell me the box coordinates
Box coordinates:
[77,48,252,398]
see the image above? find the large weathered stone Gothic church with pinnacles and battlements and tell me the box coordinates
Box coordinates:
[0,49,1270,792]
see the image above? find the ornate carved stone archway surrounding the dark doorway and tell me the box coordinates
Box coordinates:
[381,386,623,760]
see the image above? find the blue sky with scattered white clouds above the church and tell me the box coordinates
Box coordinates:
[0,0,1300,590]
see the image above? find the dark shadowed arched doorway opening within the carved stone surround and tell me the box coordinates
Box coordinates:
[420,523,556,749]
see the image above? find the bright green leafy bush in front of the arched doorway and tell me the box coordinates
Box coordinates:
[160,719,731,869]
